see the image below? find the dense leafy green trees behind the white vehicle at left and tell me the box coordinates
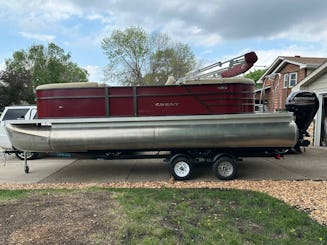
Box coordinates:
[0,43,88,107]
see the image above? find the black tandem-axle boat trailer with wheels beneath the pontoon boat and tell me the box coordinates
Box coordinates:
[24,148,290,181]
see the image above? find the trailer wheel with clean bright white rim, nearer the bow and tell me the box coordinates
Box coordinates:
[169,156,193,180]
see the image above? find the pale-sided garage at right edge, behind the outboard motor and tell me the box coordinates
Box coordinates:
[292,62,327,147]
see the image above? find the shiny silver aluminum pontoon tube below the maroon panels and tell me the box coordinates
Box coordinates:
[7,113,298,152]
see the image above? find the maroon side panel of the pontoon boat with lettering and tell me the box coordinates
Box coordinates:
[36,83,254,118]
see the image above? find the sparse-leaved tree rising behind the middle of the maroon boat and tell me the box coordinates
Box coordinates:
[102,27,195,85]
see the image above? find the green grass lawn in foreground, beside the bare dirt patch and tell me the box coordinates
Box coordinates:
[0,188,327,244]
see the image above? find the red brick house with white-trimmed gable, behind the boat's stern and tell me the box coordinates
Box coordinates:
[256,56,327,111]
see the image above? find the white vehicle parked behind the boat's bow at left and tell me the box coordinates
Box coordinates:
[0,105,38,160]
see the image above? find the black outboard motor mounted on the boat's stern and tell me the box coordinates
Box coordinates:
[285,91,319,151]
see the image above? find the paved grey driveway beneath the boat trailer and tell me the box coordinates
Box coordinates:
[0,148,327,183]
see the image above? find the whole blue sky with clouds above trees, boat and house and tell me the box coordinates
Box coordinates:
[0,0,327,82]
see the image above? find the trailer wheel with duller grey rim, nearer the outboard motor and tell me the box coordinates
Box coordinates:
[212,156,237,180]
